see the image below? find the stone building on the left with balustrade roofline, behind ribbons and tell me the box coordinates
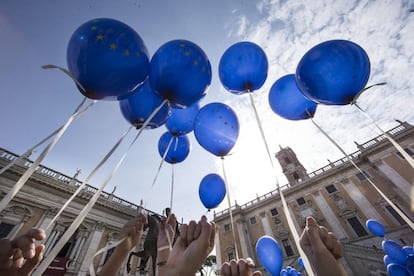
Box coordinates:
[0,149,160,275]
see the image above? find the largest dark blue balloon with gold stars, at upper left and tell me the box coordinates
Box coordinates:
[66,18,149,100]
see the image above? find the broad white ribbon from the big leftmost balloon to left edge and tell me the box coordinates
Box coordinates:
[0,97,87,212]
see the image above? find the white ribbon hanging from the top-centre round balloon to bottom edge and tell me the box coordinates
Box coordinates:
[248,93,314,276]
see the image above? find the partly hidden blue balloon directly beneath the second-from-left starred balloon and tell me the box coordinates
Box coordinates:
[165,103,200,136]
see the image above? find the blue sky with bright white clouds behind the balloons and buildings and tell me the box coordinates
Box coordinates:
[0,0,414,222]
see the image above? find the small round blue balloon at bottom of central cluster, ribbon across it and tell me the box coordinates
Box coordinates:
[158,131,190,164]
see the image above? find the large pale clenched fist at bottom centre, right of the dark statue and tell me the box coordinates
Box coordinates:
[158,216,216,276]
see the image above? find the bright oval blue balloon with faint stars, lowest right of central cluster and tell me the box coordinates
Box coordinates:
[194,103,239,156]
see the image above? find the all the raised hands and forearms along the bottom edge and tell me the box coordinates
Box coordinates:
[0,213,347,276]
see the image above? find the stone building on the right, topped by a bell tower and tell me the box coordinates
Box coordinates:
[214,122,414,275]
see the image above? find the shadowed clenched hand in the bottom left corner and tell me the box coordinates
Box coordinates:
[0,228,46,276]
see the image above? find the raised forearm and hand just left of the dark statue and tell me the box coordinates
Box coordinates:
[99,213,148,276]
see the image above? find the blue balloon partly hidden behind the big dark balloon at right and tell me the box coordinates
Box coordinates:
[269,74,317,120]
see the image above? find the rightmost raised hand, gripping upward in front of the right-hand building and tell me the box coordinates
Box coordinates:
[300,216,348,276]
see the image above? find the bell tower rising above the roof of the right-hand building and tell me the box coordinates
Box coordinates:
[275,146,309,185]
